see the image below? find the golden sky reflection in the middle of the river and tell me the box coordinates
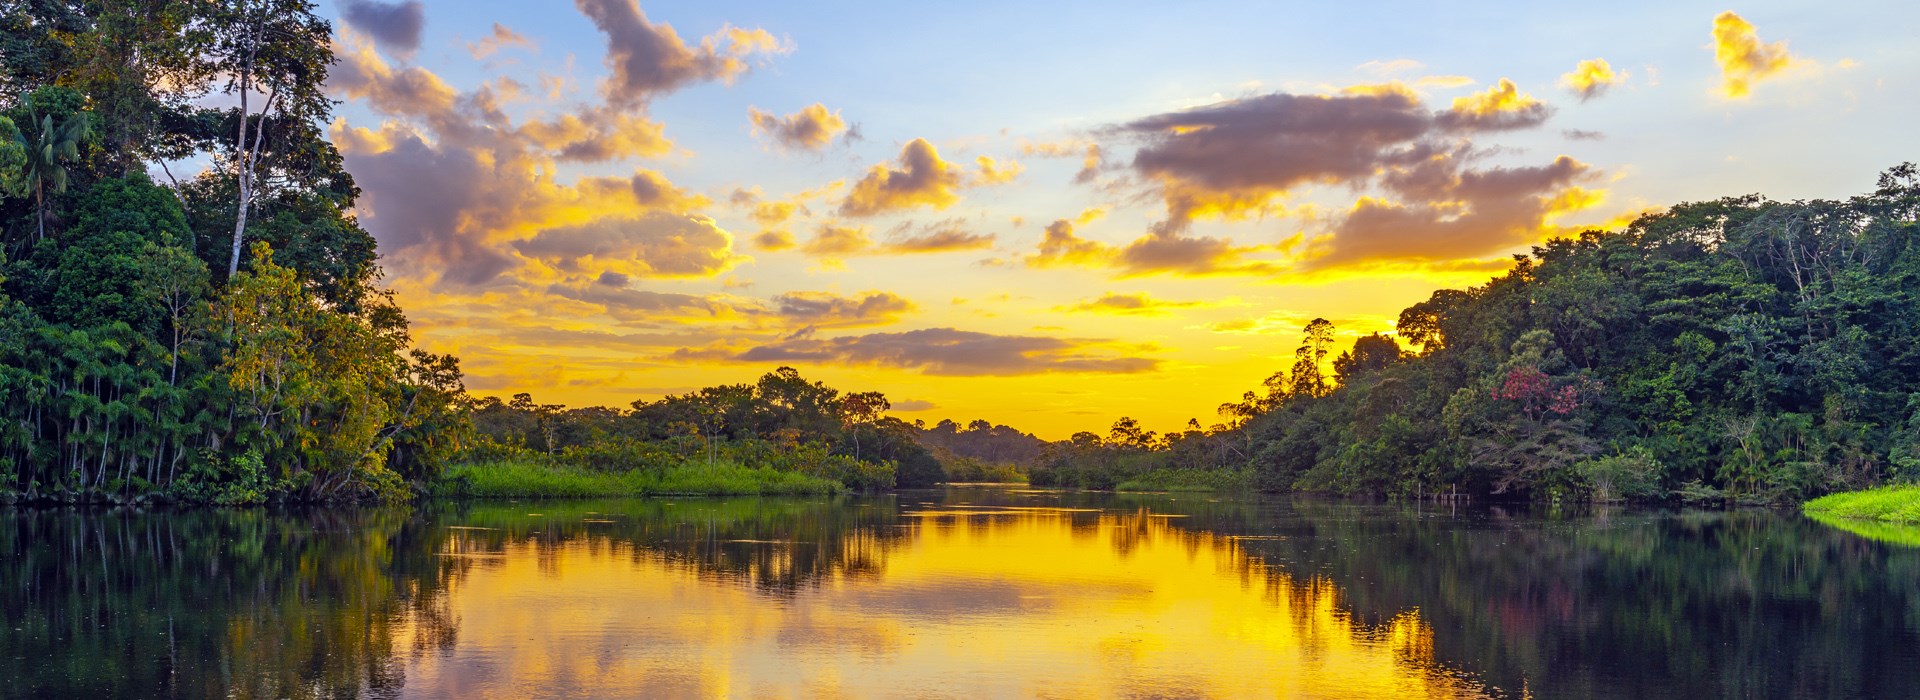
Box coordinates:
[378,506,1484,698]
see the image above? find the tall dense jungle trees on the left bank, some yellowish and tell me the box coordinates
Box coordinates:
[0,0,467,504]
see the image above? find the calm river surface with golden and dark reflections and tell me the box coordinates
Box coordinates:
[0,487,1920,700]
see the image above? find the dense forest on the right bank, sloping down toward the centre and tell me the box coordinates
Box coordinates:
[1033,163,1920,502]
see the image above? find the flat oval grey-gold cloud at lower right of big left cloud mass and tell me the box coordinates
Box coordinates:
[513,211,739,278]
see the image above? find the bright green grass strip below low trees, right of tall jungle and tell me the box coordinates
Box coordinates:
[436,458,847,499]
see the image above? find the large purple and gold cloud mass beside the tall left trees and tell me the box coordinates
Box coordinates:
[328,26,739,286]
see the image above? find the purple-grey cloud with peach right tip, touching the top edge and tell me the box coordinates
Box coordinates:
[574,0,785,107]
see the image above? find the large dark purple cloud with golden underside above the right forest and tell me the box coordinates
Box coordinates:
[1075,79,1586,276]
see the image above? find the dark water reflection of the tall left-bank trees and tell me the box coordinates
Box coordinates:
[0,508,455,698]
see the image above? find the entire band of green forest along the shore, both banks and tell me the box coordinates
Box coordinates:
[0,2,1920,506]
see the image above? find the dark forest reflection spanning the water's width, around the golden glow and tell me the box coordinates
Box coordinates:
[0,489,1920,698]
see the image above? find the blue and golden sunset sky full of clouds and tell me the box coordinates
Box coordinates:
[319,0,1920,439]
